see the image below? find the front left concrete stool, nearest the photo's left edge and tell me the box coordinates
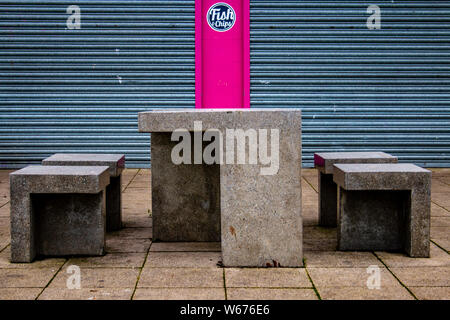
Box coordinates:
[10,166,109,262]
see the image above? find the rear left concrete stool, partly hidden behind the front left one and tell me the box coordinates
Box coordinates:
[42,153,125,231]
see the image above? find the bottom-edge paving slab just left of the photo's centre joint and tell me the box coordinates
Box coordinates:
[133,288,225,300]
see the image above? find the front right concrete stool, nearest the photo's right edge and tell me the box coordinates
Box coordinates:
[333,164,431,257]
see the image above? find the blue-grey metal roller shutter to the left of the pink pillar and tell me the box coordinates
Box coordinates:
[0,0,195,167]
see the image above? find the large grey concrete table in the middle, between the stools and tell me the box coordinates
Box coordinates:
[139,109,303,267]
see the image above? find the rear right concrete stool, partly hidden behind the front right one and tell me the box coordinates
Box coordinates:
[314,152,397,228]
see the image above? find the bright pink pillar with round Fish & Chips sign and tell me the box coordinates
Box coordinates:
[195,0,250,108]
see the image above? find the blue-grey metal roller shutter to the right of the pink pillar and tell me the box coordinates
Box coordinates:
[251,0,450,167]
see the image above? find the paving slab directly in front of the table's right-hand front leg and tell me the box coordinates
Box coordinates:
[225,268,312,288]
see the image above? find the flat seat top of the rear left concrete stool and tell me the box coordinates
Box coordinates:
[42,153,125,177]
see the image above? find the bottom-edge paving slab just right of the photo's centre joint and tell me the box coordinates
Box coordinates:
[227,288,318,300]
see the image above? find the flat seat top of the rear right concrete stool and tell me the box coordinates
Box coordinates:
[314,151,398,174]
